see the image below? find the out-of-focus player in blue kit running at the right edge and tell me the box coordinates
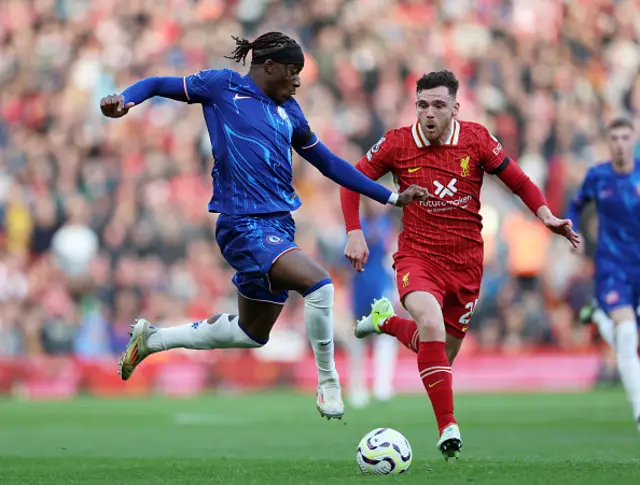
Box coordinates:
[568,118,640,430]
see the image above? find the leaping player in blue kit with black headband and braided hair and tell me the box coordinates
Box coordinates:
[100,32,427,419]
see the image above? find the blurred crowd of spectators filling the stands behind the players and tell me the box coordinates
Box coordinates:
[0,0,640,362]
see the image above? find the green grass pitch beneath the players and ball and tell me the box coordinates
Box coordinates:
[0,390,640,485]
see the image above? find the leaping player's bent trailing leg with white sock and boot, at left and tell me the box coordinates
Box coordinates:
[119,294,283,380]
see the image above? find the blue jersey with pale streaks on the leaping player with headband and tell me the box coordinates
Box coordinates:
[184,69,317,215]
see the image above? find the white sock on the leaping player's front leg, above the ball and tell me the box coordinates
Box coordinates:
[304,283,338,383]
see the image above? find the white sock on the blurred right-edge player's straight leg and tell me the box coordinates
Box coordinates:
[616,321,640,419]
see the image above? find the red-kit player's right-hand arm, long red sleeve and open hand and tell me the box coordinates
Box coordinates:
[497,158,580,248]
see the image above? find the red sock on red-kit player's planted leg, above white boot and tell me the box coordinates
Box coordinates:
[418,342,456,434]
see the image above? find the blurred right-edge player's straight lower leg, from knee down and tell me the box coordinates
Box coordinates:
[610,306,640,430]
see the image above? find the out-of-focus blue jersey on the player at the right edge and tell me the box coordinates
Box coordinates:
[569,160,640,279]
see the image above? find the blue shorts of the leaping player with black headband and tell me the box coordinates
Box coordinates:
[216,213,298,305]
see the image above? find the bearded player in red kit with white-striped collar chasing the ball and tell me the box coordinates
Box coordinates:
[340,71,579,459]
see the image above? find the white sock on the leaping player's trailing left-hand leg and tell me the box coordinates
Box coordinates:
[147,313,264,352]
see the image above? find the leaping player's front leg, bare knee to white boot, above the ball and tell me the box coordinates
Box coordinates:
[269,251,344,419]
